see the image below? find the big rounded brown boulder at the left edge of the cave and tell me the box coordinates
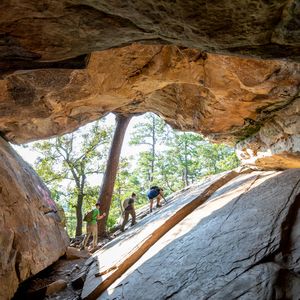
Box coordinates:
[0,138,68,300]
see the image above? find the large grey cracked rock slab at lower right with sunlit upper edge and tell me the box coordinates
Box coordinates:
[98,169,300,300]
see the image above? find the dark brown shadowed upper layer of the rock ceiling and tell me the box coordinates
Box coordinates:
[0,0,300,71]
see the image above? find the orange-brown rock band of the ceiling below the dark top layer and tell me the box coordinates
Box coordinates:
[0,44,300,167]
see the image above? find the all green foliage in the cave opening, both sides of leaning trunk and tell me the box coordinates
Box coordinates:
[28,113,239,236]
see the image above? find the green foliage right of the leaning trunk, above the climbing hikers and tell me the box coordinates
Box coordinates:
[127,114,239,198]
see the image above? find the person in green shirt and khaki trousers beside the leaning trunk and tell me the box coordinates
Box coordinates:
[80,203,106,250]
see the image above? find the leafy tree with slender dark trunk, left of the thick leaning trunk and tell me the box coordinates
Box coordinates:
[33,122,110,236]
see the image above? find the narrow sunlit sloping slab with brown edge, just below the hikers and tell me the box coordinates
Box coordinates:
[81,171,238,299]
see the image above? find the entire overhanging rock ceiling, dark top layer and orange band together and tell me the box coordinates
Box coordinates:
[0,0,300,165]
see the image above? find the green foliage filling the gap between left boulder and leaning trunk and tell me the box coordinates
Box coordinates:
[32,121,112,236]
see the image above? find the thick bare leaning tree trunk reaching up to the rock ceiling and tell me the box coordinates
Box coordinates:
[98,115,132,237]
